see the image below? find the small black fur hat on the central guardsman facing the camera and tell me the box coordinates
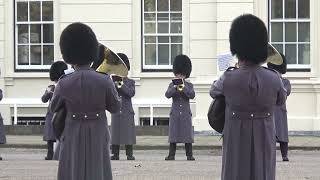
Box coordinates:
[172,54,192,78]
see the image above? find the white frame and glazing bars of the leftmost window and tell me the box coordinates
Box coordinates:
[13,0,56,72]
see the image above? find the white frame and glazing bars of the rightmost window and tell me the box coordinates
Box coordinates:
[268,0,312,72]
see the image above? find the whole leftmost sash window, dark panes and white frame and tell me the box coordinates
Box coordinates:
[15,0,54,70]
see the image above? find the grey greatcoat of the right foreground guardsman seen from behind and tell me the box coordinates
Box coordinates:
[210,65,286,180]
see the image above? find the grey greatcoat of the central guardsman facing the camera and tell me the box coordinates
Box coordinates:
[165,81,195,143]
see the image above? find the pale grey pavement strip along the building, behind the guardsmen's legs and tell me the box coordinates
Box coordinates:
[0,135,320,150]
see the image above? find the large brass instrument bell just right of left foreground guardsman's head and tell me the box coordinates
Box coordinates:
[91,44,128,88]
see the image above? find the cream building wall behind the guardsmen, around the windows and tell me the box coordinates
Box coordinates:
[0,0,320,131]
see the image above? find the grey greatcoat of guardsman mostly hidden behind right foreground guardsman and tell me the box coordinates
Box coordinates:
[274,78,291,142]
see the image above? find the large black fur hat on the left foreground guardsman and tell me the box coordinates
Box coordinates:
[60,22,98,65]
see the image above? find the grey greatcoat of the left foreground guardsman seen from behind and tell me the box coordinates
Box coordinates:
[50,66,120,180]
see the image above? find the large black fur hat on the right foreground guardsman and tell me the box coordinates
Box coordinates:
[229,14,268,64]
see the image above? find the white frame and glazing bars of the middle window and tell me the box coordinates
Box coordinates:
[141,0,184,72]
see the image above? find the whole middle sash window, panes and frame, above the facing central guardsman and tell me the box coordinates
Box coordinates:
[142,0,182,70]
